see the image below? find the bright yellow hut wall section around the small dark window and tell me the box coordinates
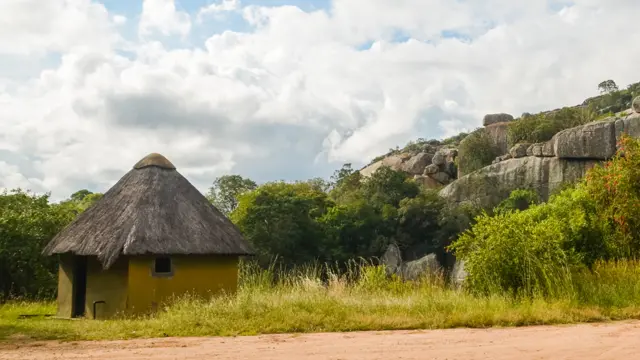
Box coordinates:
[129,255,238,313]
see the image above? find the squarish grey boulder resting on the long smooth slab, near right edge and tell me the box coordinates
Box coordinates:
[552,120,616,160]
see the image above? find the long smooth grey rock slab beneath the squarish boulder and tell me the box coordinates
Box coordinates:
[440,156,599,209]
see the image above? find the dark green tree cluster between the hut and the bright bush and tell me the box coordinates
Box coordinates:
[231,164,452,266]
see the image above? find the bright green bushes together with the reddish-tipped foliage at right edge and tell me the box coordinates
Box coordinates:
[451,136,640,295]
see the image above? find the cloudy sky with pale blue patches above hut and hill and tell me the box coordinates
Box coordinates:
[0,0,640,200]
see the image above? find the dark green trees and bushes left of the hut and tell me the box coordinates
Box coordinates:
[0,189,76,301]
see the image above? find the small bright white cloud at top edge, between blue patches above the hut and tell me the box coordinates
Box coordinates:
[138,0,191,36]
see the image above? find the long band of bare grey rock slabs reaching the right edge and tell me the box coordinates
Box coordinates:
[440,112,640,208]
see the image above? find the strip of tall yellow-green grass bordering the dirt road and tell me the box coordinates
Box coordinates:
[0,262,640,341]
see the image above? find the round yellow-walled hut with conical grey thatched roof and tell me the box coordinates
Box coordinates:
[44,154,252,318]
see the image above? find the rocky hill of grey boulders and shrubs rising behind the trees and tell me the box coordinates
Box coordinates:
[360,83,640,208]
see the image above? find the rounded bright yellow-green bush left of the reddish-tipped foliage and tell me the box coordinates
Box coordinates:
[451,190,585,295]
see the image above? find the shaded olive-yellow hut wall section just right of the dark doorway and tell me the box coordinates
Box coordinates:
[85,256,129,319]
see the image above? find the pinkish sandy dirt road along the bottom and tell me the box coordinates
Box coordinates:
[0,321,640,360]
